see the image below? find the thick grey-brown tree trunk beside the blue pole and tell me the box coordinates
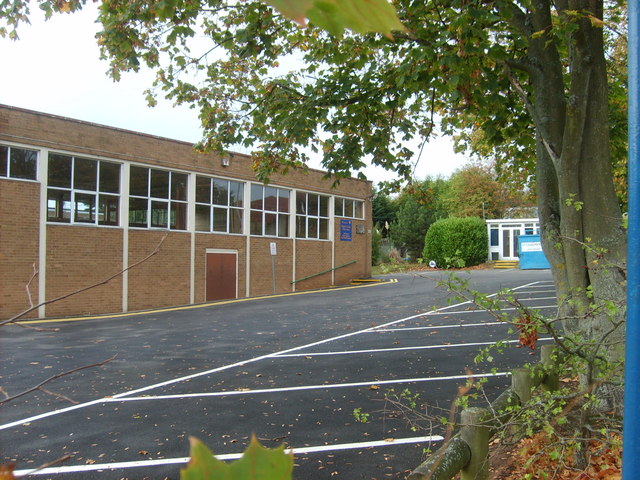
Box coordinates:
[529,1,626,407]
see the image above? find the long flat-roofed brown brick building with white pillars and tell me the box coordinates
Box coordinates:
[0,105,372,319]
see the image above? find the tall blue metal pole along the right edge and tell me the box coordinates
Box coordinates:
[622,0,640,480]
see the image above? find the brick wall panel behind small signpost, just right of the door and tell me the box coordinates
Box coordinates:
[249,237,293,297]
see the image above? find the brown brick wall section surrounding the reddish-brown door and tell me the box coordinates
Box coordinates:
[195,233,247,303]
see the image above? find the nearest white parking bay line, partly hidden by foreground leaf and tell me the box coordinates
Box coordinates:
[13,435,444,476]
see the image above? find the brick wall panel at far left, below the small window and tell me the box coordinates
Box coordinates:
[0,179,40,320]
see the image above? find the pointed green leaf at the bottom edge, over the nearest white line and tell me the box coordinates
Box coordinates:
[180,436,293,480]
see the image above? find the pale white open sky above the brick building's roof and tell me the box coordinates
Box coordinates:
[0,2,467,186]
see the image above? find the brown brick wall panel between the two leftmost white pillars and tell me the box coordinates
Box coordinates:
[46,225,122,317]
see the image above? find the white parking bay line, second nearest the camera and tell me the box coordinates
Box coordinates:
[103,372,511,403]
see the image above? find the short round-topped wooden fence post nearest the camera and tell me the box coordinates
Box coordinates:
[460,407,489,480]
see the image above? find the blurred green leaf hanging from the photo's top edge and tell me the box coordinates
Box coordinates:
[263,0,405,38]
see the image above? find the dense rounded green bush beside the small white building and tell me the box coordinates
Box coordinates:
[422,217,489,268]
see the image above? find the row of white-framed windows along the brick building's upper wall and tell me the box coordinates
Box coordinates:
[0,145,364,240]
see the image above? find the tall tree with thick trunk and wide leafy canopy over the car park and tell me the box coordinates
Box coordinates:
[0,0,626,404]
